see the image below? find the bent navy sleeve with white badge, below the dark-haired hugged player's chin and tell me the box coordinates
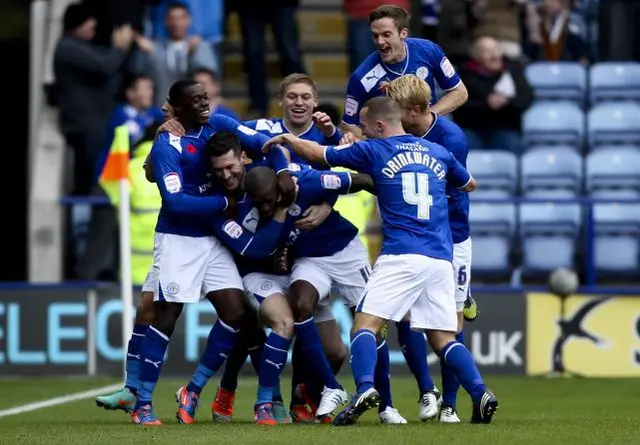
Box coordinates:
[212,214,284,259]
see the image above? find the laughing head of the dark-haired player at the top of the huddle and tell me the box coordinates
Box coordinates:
[369,5,409,63]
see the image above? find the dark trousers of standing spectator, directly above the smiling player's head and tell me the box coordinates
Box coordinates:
[234,0,306,120]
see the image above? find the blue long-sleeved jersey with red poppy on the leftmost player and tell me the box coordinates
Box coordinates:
[150,115,287,237]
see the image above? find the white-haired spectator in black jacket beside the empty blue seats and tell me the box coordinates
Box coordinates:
[453,37,533,154]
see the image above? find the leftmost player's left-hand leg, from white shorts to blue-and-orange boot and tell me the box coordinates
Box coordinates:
[131,233,212,425]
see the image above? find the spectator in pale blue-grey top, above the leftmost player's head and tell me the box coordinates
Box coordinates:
[133,2,218,107]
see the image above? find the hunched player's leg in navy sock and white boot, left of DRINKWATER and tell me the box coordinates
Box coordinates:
[289,258,347,416]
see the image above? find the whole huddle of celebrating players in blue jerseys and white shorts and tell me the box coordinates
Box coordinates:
[96,6,498,425]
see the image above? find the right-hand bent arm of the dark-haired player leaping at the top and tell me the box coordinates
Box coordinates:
[431,43,469,115]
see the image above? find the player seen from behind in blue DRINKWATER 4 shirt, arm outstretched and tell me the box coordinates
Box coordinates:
[264,97,498,425]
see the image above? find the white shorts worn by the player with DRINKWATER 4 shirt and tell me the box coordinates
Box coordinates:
[357,254,458,332]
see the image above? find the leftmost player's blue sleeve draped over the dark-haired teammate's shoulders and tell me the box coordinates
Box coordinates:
[209,114,289,173]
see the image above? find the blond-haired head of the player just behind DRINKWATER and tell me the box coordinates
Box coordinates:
[385,74,431,131]
